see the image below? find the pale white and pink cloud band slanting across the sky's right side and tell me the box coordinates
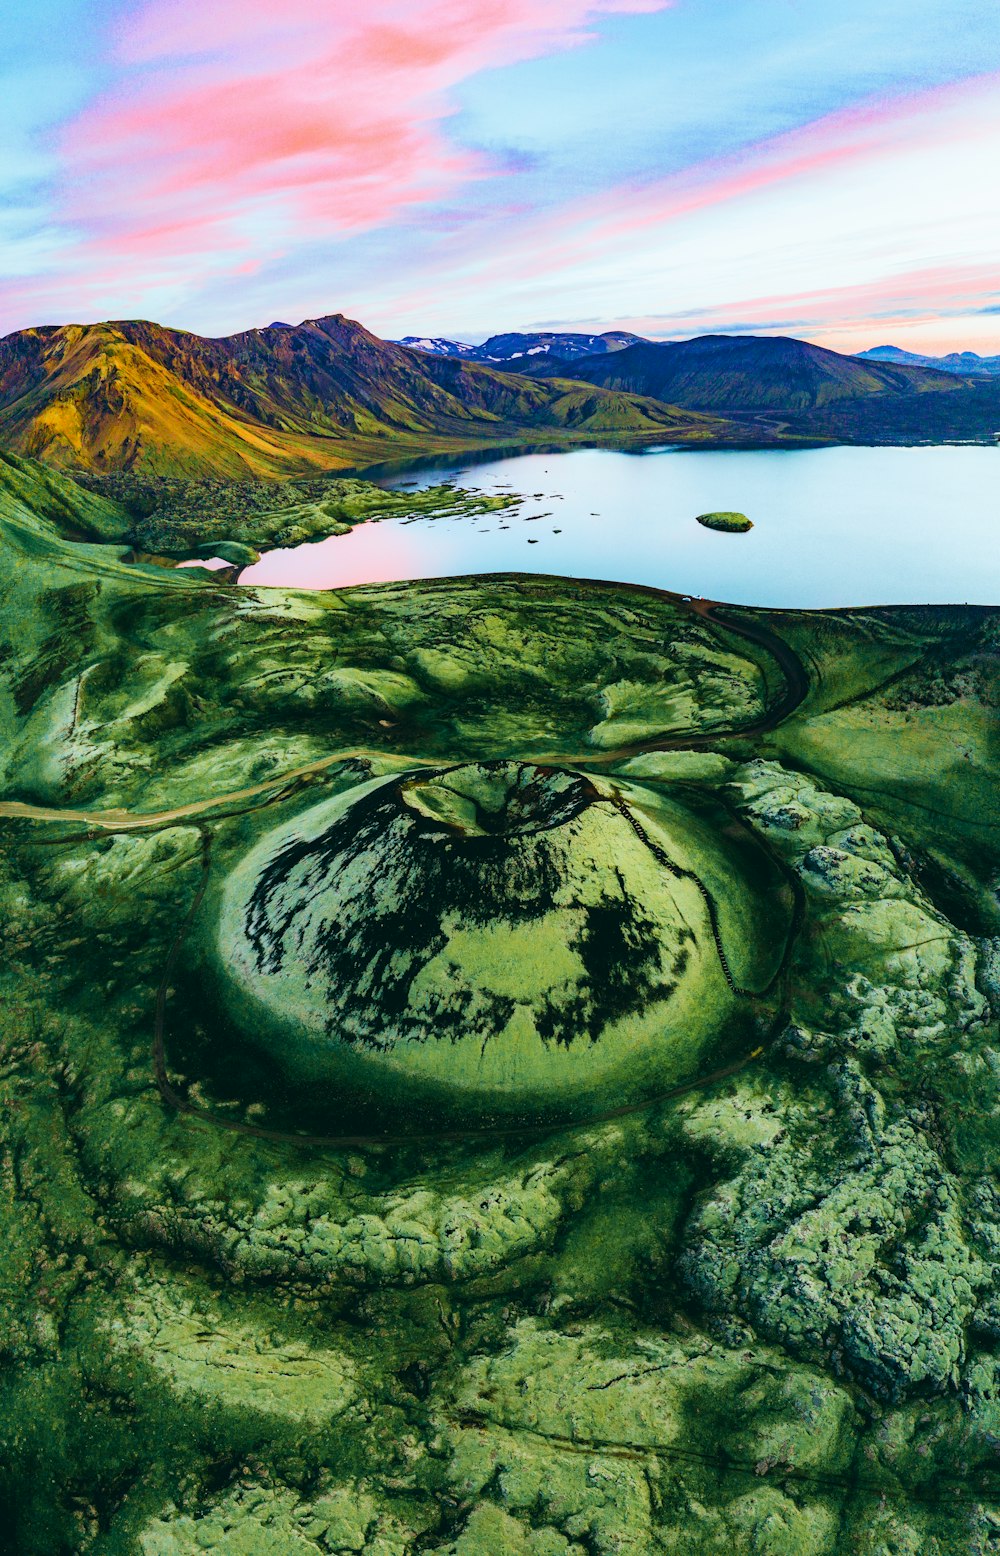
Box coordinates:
[362,75,1000,350]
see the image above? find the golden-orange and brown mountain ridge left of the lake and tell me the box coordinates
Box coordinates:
[0,314,725,478]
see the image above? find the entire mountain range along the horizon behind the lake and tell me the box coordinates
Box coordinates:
[0,314,1000,479]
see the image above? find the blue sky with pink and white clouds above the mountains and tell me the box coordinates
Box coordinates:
[0,0,1000,353]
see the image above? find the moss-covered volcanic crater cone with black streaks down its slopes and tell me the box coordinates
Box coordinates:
[215,762,758,1117]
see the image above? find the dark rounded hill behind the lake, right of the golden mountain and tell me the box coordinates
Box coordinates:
[538,335,963,415]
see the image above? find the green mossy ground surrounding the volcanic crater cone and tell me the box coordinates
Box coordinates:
[0,467,1000,1556]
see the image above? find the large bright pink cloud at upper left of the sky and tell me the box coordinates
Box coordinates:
[35,0,672,300]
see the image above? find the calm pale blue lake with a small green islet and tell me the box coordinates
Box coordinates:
[241,445,1000,607]
